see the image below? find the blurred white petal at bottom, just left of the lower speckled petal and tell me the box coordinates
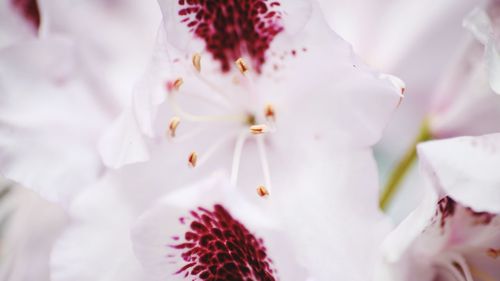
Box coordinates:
[50,177,144,281]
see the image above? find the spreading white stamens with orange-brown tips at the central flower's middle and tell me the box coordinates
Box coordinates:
[166,54,276,197]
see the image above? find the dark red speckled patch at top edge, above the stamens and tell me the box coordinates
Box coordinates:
[178,0,283,72]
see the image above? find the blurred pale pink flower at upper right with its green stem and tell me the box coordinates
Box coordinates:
[321,0,500,220]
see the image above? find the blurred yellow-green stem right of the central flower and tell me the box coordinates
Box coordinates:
[380,119,432,211]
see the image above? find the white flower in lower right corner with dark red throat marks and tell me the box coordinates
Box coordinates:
[380,134,500,281]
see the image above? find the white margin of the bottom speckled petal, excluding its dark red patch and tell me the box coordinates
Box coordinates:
[132,174,305,280]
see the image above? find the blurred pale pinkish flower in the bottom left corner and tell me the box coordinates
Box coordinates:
[0,180,68,281]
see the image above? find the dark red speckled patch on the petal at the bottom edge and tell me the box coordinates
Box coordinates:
[171,205,276,281]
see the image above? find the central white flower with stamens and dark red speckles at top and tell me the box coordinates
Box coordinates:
[100,0,401,199]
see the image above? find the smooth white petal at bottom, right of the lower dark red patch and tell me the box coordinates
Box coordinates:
[273,148,390,280]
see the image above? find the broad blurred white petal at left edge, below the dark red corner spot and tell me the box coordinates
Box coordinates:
[0,38,108,201]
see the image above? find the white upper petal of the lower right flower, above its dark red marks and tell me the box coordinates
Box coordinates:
[419,134,500,213]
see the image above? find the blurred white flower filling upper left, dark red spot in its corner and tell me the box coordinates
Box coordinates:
[0,0,160,202]
